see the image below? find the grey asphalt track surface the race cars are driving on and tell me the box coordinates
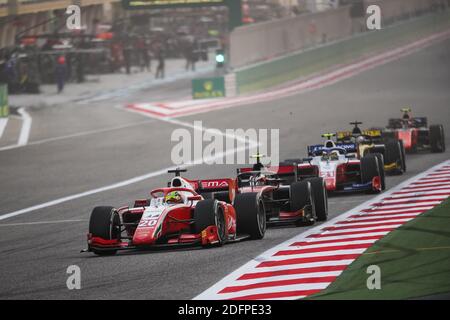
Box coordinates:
[0,41,450,299]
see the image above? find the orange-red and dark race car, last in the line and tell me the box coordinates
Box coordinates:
[383,108,445,152]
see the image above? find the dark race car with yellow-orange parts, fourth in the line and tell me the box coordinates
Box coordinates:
[336,121,406,174]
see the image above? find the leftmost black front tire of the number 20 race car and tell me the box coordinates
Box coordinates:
[89,207,120,256]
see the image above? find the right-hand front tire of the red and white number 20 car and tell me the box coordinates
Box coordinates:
[194,199,227,246]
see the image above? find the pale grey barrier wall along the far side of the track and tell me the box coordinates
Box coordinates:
[230,0,450,69]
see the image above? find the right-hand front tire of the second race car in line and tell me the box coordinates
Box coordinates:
[290,181,317,226]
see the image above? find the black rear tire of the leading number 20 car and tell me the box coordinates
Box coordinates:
[234,192,267,239]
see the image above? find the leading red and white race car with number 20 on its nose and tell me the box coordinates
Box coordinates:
[84,169,266,255]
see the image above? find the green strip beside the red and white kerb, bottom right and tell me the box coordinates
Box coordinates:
[309,198,450,300]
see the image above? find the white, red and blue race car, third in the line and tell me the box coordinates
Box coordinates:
[284,133,385,193]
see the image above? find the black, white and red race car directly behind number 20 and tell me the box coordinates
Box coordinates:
[199,155,328,226]
